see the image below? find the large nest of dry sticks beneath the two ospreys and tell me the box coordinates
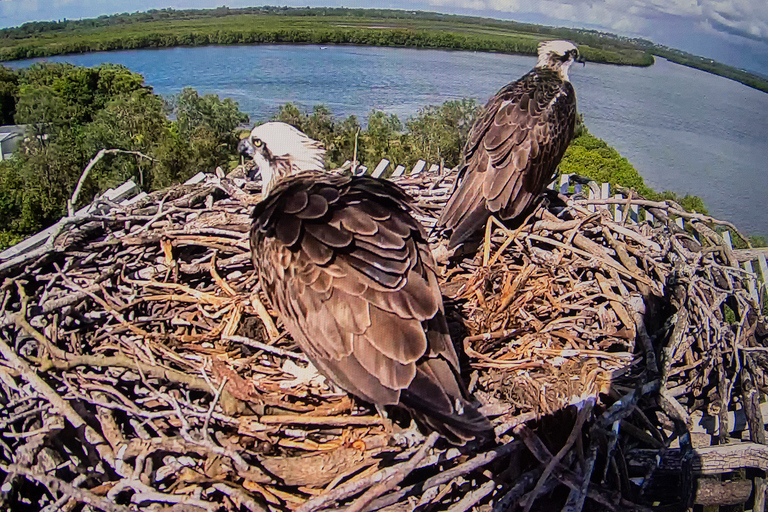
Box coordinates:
[0,165,768,512]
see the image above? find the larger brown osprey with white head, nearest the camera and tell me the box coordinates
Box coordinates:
[239,122,491,444]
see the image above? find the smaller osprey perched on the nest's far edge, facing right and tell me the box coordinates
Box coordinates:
[437,41,583,248]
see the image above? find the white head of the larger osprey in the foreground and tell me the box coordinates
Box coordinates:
[237,121,325,195]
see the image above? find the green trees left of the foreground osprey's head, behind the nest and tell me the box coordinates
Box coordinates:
[0,64,248,245]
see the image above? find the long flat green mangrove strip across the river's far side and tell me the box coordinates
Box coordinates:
[0,7,653,66]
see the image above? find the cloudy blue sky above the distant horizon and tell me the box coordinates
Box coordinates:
[0,0,768,75]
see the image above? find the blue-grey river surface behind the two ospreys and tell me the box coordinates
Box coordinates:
[10,45,768,236]
